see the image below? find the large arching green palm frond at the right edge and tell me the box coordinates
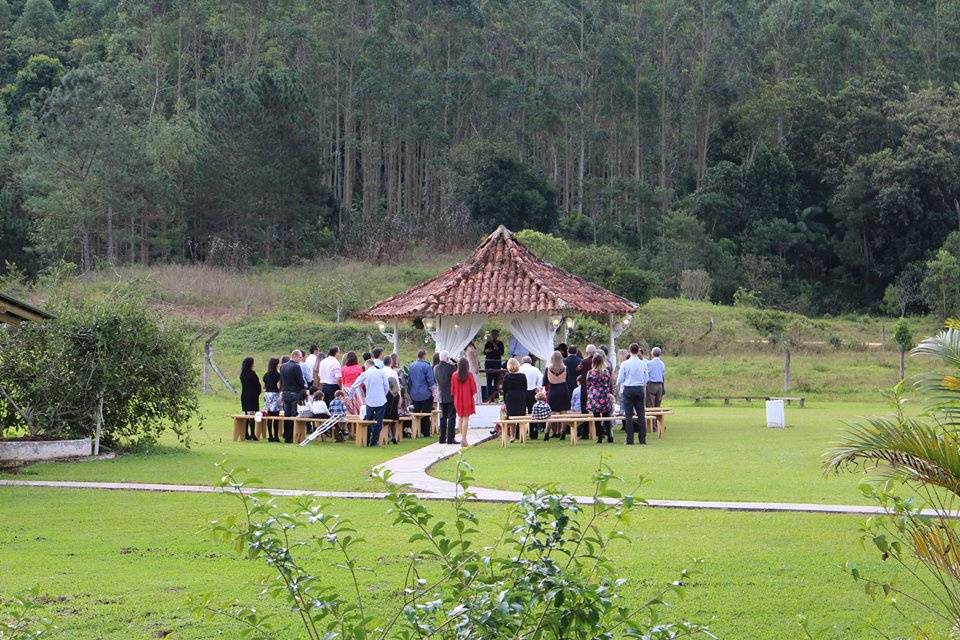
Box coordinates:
[824,416,960,496]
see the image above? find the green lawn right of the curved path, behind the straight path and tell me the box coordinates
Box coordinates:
[432,402,900,504]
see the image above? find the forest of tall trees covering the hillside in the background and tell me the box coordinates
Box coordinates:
[0,0,960,313]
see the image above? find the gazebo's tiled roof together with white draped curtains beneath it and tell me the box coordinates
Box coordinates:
[361,225,637,361]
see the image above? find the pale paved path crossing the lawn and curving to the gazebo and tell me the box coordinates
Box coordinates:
[0,405,944,516]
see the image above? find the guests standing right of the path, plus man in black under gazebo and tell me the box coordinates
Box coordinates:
[483,332,666,444]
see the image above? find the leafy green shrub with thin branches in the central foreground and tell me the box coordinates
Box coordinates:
[201,459,715,640]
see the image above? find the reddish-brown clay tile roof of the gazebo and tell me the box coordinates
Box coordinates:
[362,225,637,320]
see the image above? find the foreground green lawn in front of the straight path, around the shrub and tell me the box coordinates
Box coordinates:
[0,488,924,640]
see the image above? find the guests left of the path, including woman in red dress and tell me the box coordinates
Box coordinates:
[240,345,479,447]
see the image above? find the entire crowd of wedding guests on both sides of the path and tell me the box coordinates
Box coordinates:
[240,338,665,447]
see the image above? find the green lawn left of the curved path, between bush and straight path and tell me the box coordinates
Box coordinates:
[0,395,433,491]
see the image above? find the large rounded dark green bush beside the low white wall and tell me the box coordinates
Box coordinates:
[0,296,198,444]
